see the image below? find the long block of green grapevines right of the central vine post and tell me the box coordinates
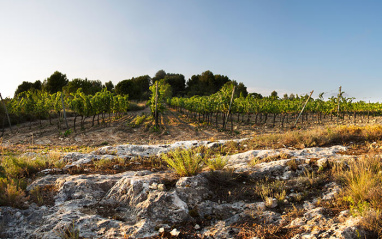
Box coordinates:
[167,85,382,128]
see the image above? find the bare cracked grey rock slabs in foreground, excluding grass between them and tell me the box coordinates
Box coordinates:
[0,141,370,239]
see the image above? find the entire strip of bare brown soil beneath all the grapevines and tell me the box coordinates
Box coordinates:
[2,107,381,147]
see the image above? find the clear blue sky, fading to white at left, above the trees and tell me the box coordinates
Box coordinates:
[0,0,382,101]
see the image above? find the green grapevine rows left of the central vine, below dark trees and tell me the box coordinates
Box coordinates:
[7,89,129,130]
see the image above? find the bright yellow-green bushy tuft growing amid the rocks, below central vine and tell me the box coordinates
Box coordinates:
[162,149,203,177]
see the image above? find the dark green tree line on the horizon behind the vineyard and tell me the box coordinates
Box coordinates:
[14,70,249,100]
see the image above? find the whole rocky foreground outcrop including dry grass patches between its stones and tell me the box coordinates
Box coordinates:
[0,140,371,239]
